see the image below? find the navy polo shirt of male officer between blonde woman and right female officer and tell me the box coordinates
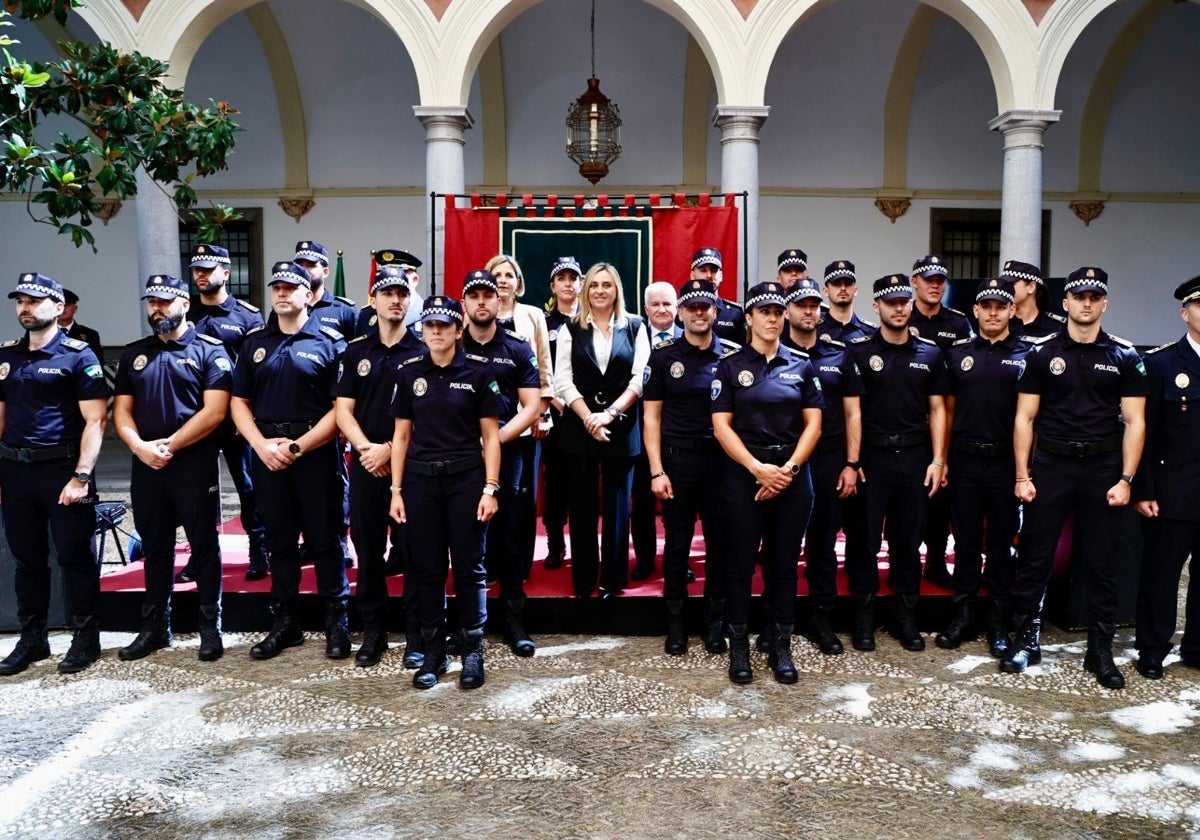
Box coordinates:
[642,335,726,438]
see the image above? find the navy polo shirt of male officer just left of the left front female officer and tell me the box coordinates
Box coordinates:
[334,330,425,443]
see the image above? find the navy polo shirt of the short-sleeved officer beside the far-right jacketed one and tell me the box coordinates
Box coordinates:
[1016,330,1150,443]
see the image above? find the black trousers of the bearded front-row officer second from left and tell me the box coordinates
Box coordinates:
[130,440,221,606]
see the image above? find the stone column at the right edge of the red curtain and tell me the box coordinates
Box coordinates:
[710,106,774,300]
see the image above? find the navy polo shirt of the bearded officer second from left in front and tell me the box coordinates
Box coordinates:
[115,326,233,440]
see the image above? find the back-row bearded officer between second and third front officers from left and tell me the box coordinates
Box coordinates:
[175,245,269,583]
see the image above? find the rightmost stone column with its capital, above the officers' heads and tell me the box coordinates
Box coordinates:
[988,110,1062,271]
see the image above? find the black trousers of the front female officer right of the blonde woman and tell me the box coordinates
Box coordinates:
[721,463,812,624]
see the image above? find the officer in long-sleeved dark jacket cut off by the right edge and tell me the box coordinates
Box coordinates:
[1133,277,1200,679]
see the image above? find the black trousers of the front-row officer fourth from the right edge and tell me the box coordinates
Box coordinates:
[846,445,930,595]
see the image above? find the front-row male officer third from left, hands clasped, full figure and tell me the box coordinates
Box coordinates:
[230,262,350,659]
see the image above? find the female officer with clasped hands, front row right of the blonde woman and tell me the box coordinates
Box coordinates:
[712,281,824,684]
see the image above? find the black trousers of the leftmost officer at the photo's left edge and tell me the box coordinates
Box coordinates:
[0,458,100,622]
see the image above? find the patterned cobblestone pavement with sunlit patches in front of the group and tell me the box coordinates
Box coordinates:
[0,632,1200,840]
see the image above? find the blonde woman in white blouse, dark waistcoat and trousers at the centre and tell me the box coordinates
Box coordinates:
[554,263,650,599]
